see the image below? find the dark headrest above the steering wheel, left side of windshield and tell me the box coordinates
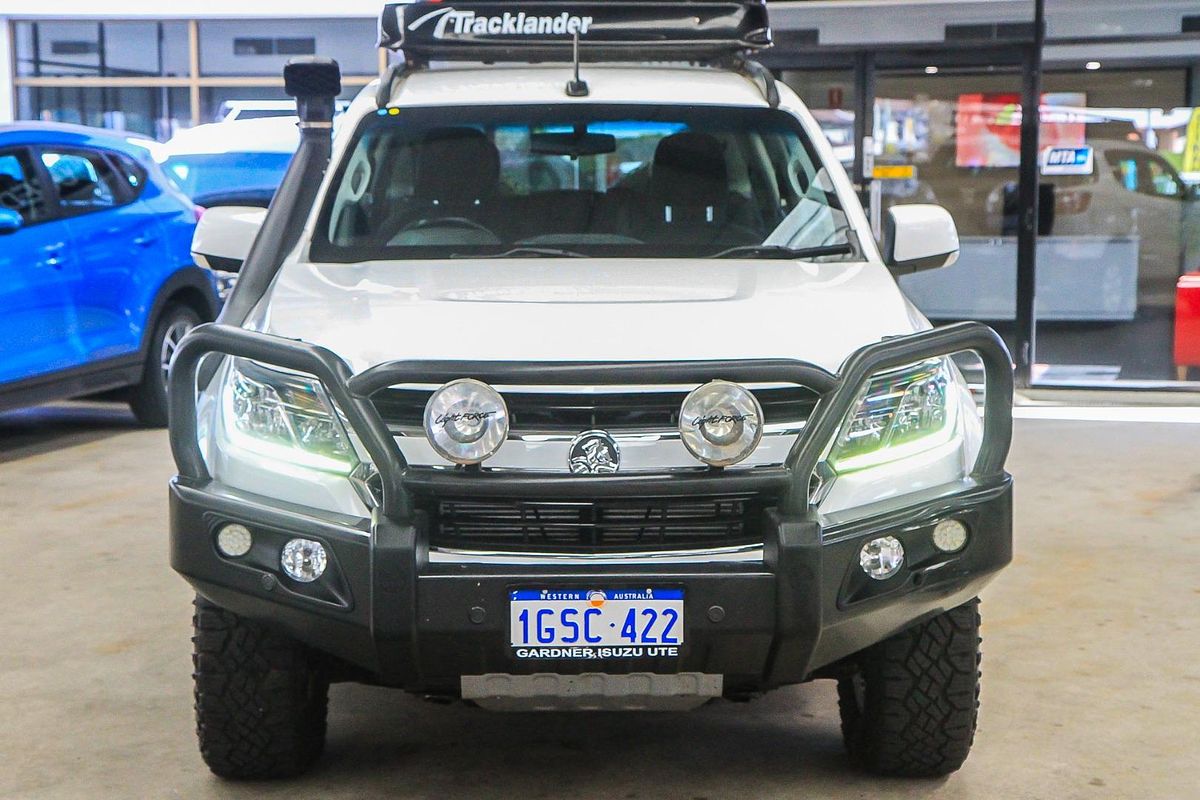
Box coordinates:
[415,127,500,205]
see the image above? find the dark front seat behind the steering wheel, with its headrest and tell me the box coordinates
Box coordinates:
[388,127,500,245]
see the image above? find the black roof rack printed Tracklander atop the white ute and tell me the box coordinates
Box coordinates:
[379,0,772,62]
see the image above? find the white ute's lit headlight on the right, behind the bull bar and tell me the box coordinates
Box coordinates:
[827,359,959,474]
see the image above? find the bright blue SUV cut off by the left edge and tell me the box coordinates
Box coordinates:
[0,122,218,426]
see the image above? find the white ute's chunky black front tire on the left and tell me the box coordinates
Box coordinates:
[192,597,329,780]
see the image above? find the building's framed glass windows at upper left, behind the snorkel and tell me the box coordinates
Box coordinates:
[12,19,380,140]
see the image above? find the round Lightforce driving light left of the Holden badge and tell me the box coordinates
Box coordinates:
[425,378,509,464]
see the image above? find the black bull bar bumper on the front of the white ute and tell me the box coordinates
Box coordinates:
[170,325,1012,694]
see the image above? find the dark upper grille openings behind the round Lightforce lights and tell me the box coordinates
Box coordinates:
[372,386,818,433]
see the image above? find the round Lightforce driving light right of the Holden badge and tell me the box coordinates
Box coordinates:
[679,380,762,467]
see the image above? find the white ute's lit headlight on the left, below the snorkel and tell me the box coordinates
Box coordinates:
[222,359,356,475]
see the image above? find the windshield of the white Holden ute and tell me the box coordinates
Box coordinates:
[312,104,858,261]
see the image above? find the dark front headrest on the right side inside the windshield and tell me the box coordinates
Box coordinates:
[652,133,730,205]
